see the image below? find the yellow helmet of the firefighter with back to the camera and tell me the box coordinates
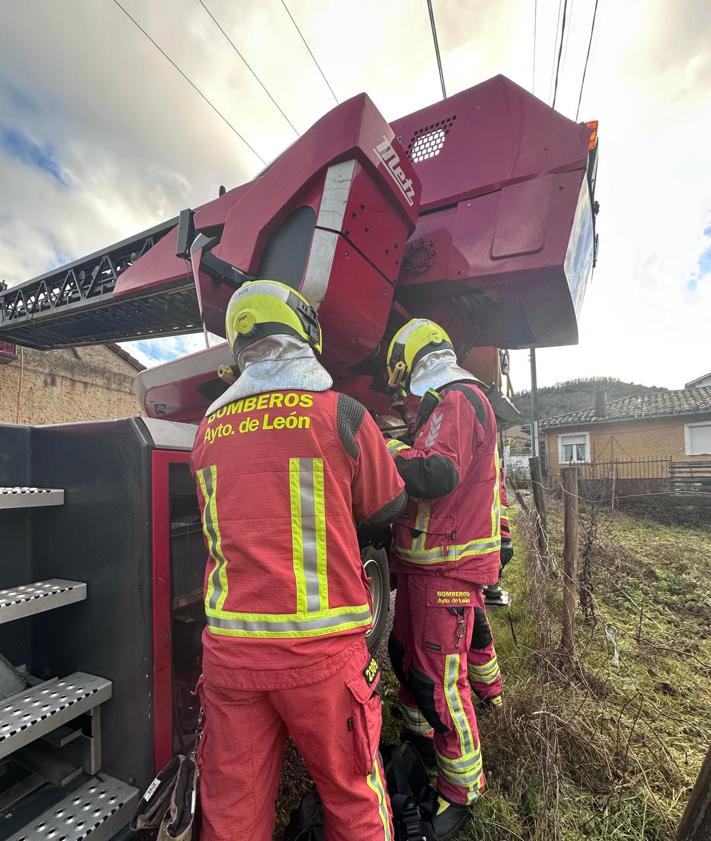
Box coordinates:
[225,280,322,359]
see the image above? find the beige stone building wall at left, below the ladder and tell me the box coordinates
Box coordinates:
[0,345,140,424]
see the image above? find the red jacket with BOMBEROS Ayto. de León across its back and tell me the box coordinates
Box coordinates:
[192,391,405,669]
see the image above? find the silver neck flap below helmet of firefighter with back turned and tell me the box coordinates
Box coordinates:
[205,335,333,415]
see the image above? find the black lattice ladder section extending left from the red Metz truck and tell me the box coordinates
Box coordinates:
[0,218,200,350]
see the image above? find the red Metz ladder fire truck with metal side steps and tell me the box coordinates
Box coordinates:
[0,76,597,841]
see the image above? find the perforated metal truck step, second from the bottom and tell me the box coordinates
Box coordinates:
[0,672,111,759]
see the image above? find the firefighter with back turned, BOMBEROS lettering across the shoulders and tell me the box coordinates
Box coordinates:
[192,281,405,841]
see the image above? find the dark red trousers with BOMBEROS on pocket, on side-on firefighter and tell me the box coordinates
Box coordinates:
[388,573,484,804]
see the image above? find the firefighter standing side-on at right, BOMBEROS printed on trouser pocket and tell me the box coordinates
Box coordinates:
[388,319,501,841]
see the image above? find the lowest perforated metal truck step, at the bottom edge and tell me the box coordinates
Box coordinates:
[8,774,139,841]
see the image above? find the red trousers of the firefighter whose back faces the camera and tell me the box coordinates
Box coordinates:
[199,642,393,841]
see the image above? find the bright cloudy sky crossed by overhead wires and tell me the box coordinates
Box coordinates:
[0,0,711,388]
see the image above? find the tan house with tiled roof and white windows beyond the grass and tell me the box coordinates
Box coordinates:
[540,386,711,473]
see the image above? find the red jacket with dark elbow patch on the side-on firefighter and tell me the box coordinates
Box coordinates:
[388,382,501,584]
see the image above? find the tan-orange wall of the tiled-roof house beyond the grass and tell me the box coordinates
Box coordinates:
[545,413,711,473]
